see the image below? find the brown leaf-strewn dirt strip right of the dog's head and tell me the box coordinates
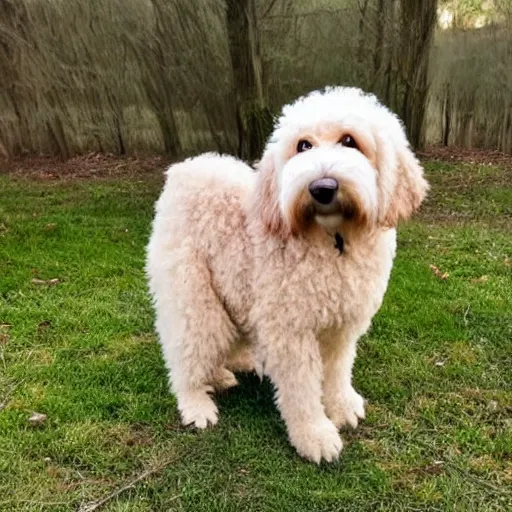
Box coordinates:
[417,146,512,169]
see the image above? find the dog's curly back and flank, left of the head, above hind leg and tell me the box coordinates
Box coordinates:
[146,153,256,336]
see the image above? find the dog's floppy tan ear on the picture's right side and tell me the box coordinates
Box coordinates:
[384,140,429,226]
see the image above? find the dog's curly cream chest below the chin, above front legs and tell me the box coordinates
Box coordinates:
[255,230,396,331]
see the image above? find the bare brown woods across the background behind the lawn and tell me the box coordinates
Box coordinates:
[0,0,512,160]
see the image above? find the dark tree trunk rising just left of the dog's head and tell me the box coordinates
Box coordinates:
[227,0,272,161]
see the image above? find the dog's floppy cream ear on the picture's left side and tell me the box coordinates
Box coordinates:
[252,151,290,239]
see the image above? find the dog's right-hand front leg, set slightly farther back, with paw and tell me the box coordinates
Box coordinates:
[322,337,365,428]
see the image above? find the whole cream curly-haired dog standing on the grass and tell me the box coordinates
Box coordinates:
[147,87,428,462]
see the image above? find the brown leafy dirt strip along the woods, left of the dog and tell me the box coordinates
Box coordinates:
[0,153,171,181]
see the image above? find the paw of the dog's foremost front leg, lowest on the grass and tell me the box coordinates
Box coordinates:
[290,418,343,464]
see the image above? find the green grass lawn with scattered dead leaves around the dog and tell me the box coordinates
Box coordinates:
[0,157,512,512]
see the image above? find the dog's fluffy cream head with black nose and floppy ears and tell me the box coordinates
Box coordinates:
[254,87,428,238]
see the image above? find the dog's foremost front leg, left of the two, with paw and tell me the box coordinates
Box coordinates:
[260,329,343,463]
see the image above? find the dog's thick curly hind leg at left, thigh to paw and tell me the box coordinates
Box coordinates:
[153,255,236,429]
